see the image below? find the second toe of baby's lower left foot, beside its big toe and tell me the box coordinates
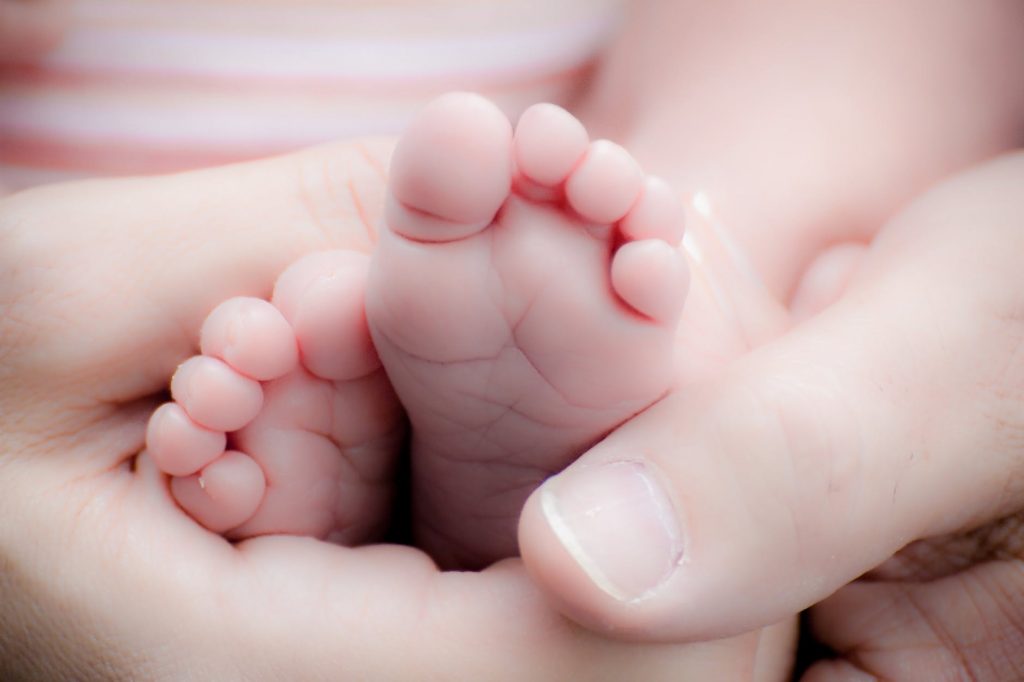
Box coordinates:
[200,296,298,381]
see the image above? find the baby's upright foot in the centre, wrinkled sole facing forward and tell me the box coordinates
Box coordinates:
[367,93,688,568]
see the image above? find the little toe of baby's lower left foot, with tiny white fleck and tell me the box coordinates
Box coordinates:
[171,451,266,532]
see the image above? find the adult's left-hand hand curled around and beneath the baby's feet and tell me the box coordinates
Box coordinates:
[0,141,763,680]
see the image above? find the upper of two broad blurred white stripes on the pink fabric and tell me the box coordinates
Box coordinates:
[46,5,615,81]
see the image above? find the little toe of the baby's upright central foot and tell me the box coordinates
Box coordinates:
[611,240,689,325]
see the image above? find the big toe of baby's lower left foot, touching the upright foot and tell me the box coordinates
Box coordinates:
[273,251,380,381]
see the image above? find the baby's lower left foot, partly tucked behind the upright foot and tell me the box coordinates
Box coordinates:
[146,251,404,544]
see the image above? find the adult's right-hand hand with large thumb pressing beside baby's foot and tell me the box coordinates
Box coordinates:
[520,154,1024,679]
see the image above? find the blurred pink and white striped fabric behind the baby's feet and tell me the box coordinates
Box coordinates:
[0,0,622,188]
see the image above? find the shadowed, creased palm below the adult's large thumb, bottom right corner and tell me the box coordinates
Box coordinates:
[803,510,1024,682]
